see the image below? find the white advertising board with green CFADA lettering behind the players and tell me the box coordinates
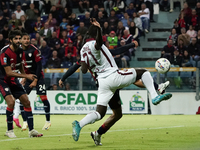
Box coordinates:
[0,90,148,114]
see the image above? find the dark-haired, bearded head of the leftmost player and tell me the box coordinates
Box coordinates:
[8,30,22,50]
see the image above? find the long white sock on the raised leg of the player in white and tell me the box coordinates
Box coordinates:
[141,71,158,99]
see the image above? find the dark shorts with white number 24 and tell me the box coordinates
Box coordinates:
[24,76,47,95]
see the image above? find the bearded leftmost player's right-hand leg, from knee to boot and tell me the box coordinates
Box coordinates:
[19,94,43,137]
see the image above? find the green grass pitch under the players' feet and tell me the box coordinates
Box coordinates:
[0,115,200,150]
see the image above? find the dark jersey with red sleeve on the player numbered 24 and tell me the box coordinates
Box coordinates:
[24,44,44,76]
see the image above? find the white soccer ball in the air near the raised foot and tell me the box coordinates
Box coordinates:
[155,58,171,74]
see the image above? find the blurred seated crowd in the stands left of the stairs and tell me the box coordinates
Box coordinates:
[0,0,159,68]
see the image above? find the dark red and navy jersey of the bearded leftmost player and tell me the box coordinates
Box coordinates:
[0,45,25,84]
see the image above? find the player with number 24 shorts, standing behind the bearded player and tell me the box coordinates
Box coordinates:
[20,33,51,130]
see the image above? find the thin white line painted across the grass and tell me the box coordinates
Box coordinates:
[0,125,184,142]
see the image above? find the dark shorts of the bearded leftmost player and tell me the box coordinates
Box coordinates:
[0,79,26,99]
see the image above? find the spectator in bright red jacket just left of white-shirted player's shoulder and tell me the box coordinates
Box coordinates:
[65,39,77,64]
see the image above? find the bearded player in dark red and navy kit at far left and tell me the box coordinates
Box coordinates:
[0,30,43,138]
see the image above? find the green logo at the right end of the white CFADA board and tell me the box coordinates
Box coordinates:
[130,92,145,111]
